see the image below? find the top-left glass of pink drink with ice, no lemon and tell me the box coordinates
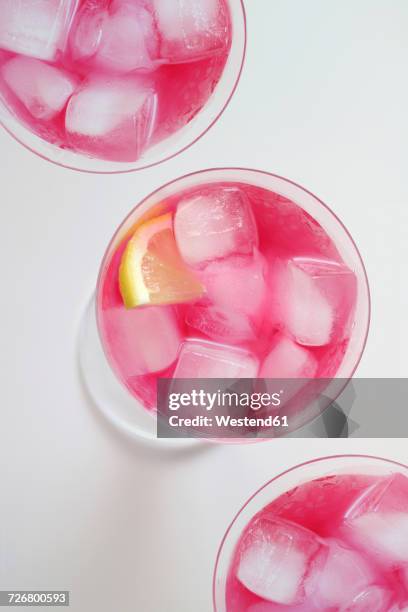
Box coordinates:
[0,0,246,172]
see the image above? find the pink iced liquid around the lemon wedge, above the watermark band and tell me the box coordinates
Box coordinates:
[97,183,356,410]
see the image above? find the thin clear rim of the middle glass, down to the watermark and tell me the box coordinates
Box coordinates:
[95,166,371,397]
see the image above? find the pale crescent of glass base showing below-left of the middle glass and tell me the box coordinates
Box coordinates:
[79,295,200,448]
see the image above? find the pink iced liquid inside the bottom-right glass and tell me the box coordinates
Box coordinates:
[226,474,408,612]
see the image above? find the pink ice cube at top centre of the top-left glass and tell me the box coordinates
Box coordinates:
[96,1,158,72]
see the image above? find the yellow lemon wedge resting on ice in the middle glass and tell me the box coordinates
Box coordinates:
[119,213,204,308]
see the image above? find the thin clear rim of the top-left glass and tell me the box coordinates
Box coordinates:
[0,0,248,175]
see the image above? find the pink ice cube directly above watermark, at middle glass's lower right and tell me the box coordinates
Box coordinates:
[260,336,317,379]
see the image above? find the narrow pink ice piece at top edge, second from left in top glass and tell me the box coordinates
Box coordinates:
[70,0,109,60]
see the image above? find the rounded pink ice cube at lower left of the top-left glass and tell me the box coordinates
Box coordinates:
[1,56,77,120]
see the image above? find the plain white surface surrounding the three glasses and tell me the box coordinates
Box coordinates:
[0,0,408,612]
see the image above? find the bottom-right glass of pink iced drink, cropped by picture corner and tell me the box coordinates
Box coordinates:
[214,456,408,612]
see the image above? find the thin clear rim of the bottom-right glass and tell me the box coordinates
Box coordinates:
[212,453,408,612]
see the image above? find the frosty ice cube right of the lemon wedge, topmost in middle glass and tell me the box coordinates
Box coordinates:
[174,187,258,266]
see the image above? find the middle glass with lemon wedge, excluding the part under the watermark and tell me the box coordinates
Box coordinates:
[78,169,369,437]
